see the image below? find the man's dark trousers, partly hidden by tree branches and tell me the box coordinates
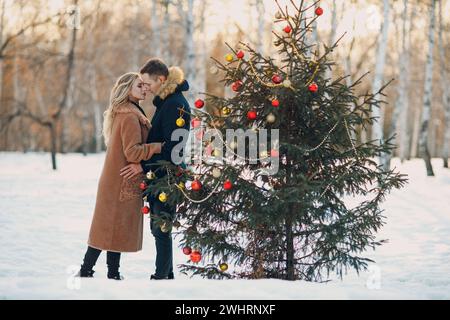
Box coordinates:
[150,197,175,279]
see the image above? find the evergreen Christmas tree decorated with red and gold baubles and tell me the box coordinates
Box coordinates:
[144,2,406,281]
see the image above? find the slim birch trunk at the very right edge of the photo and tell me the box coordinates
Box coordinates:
[439,0,450,168]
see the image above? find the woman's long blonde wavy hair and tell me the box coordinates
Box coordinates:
[102,72,139,146]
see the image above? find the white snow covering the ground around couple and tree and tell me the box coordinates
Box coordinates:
[0,153,450,300]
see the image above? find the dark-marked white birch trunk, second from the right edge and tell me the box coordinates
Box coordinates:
[419,0,436,176]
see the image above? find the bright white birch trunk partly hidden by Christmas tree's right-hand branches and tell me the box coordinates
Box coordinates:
[372,0,391,165]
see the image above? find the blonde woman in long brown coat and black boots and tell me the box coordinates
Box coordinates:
[79,73,161,280]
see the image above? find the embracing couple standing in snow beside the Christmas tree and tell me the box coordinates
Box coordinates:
[79,59,190,280]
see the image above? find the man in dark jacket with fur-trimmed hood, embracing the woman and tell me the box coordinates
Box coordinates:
[122,59,191,280]
